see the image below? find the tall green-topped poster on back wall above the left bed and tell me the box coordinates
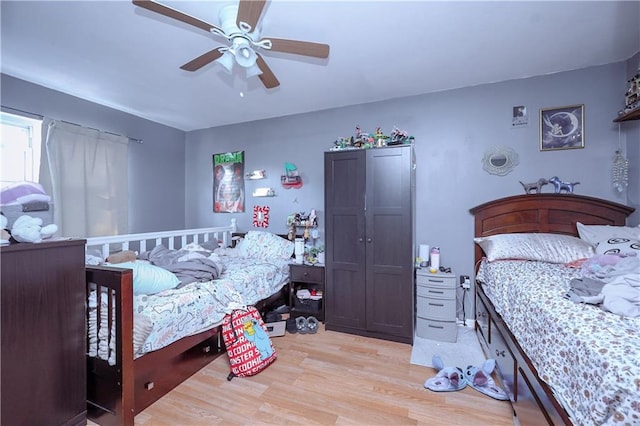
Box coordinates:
[213,151,244,213]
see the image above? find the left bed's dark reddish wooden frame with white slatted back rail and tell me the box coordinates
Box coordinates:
[86,220,287,426]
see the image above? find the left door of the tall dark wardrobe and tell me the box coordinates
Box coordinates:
[325,151,366,331]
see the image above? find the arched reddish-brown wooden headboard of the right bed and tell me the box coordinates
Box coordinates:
[470,194,635,265]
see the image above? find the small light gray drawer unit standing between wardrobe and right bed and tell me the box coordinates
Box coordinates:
[416,268,458,342]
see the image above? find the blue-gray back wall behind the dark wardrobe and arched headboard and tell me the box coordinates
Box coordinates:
[186,62,639,317]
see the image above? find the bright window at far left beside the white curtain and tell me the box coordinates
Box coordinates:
[0,112,42,187]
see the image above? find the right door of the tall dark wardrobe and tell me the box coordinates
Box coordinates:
[365,146,413,341]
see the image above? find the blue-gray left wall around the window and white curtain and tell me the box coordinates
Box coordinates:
[0,74,186,233]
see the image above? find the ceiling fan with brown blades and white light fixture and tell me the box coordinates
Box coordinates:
[133,0,329,89]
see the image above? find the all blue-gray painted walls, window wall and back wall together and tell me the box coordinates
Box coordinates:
[1,55,640,317]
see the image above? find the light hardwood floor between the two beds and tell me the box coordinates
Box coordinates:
[90,325,514,426]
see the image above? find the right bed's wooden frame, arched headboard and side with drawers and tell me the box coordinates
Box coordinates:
[470,194,634,426]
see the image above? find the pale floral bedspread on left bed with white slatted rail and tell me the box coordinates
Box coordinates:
[134,256,289,357]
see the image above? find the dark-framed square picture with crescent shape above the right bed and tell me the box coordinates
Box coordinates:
[540,105,584,151]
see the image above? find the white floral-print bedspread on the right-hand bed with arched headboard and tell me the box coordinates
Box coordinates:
[477,261,640,425]
